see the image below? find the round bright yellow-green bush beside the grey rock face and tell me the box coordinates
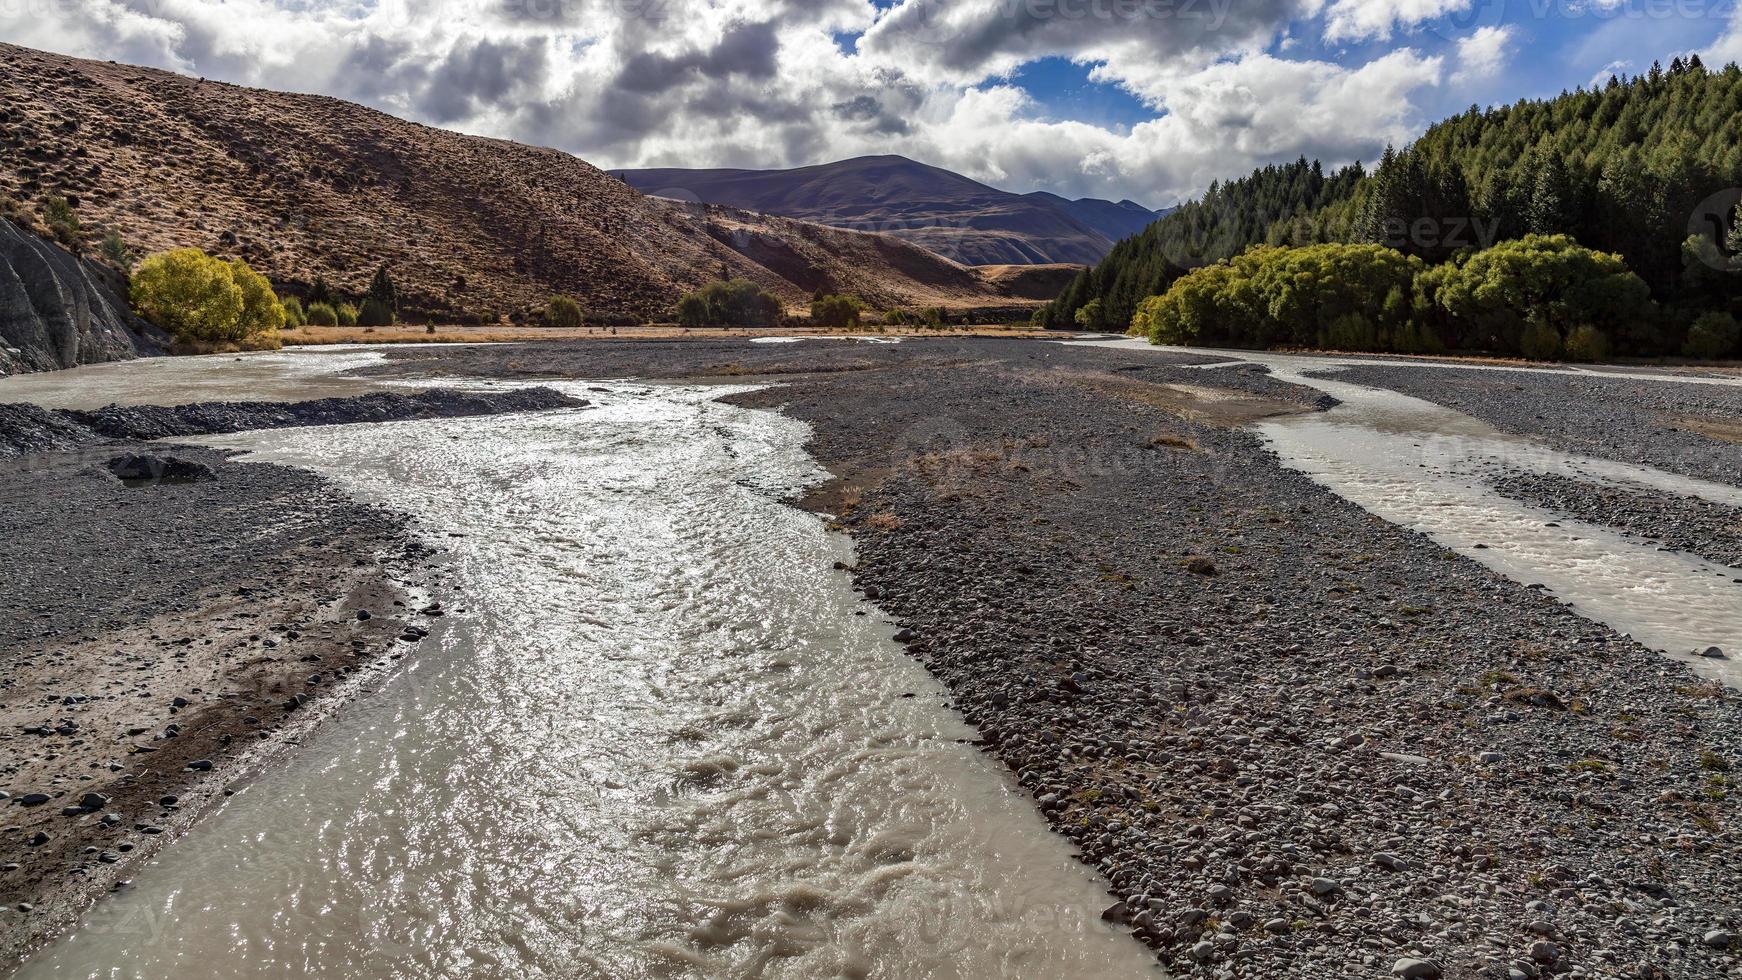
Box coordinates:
[132,249,284,343]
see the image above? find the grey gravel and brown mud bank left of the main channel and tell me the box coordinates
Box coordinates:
[0,390,578,970]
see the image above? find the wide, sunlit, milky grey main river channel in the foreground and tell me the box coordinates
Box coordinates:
[21,362,1157,978]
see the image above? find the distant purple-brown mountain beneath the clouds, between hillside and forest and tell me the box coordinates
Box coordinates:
[611,157,1165,265]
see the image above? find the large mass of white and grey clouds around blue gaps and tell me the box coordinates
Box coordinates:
[0,0,1463,205]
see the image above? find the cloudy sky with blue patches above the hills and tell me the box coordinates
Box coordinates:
[0,0,1742,207]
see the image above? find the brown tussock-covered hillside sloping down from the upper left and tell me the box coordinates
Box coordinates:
[0,44,1026,319]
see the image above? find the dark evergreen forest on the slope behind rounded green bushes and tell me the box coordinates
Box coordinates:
[1038,57,1742,353]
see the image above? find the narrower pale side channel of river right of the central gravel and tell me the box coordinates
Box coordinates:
[1066,339,1742,688]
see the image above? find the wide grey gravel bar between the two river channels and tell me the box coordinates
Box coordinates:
[360,341,1742,978]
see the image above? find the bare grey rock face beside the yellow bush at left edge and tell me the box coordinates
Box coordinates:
[0,218,159,374]
